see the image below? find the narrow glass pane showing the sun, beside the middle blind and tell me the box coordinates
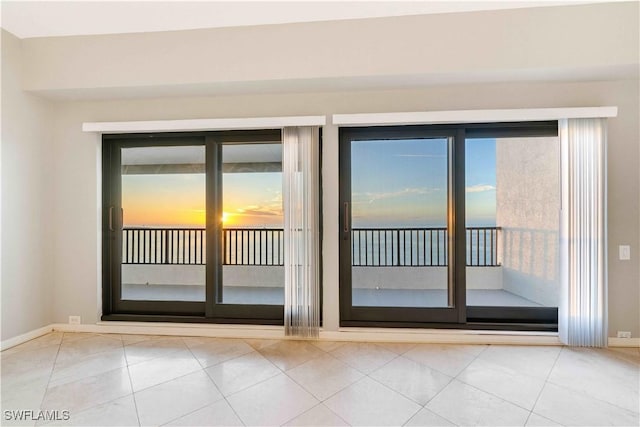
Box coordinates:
[222,143,284,305]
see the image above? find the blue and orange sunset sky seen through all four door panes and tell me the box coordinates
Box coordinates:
[122,139,496,228]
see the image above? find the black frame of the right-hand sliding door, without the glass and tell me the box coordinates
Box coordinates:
[339,121,558,331]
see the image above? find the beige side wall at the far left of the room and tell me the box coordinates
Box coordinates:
[0,31,55,340]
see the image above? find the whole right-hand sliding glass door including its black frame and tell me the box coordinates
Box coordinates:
[340,122,560,330]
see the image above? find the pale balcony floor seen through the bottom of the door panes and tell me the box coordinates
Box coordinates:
[122,285,541,307]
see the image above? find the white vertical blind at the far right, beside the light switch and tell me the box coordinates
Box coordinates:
[558,118,608,347]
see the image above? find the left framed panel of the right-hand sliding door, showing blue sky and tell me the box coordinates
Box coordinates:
[340,128,464,324]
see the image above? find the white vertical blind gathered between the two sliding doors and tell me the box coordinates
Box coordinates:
[282,126,320,338]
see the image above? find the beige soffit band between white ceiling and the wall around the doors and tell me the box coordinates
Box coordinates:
[17,2,640,97]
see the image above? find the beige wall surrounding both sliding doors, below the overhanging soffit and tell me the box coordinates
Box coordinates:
[46,80,640,336]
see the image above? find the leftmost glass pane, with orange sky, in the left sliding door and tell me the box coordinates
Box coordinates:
[121,146,206,301]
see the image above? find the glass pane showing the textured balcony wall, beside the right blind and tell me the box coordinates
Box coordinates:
[465,137,560,307]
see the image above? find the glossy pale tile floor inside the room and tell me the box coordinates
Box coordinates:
[0,332,640,426]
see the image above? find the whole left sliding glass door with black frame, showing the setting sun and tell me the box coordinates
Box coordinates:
[103,130,284,323]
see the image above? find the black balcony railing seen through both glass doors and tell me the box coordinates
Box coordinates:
[122,227,500,267]
